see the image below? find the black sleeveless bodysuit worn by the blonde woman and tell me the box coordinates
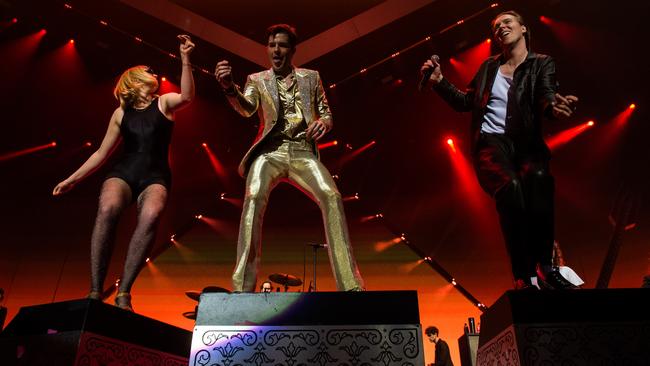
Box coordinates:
[106,98,174,201]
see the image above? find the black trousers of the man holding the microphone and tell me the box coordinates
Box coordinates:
[474,134,555,280]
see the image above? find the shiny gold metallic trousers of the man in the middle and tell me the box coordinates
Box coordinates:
[232,142,363,292]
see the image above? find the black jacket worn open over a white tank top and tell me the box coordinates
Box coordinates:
[433,52,557,155]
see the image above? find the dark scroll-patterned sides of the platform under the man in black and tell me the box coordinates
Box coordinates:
[476,323,650,366]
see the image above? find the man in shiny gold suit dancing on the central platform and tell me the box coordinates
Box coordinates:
[215,24,363,292]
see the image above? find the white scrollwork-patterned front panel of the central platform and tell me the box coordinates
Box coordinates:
[190,324,424,366]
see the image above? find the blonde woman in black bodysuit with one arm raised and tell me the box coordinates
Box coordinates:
[52,35,194,311]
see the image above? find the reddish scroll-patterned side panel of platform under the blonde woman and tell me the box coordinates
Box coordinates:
[74,332,187,366]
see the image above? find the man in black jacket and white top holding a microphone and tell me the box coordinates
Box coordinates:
[421,11,578,289]
